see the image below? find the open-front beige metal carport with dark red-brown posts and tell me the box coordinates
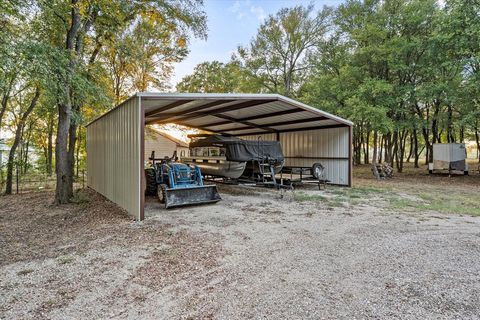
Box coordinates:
[87,93,353,220]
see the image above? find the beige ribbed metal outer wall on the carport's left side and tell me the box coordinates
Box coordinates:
[87,97,143,220]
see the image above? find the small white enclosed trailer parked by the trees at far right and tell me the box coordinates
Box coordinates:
[428,143,468,175]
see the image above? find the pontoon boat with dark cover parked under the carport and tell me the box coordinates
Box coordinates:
[181,134,285,180]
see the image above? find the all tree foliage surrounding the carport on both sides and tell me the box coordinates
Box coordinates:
[0,0,480,194]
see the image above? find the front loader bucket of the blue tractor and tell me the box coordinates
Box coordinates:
[165,185,222,209]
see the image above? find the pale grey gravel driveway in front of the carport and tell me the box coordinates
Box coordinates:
[144,186,480,319]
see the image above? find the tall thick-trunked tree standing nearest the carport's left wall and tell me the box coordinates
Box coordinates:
[34,0,206,203]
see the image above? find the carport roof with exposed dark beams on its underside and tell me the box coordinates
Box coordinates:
[86,92,352,136]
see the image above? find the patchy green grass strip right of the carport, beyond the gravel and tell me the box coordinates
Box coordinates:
[294,163,480,216]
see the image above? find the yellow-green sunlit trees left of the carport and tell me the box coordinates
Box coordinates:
[0,0,206,195]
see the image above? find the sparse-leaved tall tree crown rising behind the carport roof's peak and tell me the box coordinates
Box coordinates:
[234,5,332,96]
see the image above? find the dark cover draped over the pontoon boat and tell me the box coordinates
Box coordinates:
[190,135,283,162]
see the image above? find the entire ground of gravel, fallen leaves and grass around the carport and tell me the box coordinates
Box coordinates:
[0,167,480,319]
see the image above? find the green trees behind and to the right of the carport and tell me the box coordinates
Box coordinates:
[177,0,480,175]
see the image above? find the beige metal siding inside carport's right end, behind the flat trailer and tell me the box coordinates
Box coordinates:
[280,127,350,185]
